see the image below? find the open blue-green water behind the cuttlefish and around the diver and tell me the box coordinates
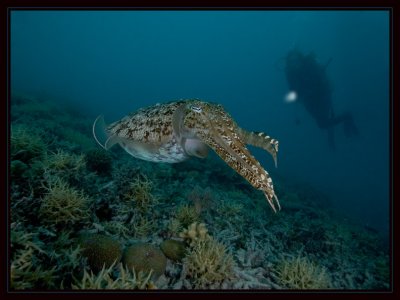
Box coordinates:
[10,11,389,231]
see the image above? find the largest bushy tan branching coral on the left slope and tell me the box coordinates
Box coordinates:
[39,178,89,226]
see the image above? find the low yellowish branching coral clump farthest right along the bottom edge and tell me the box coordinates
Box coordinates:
[276,255,331,289]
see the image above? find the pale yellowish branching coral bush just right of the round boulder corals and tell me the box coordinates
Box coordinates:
[183,236,234,289]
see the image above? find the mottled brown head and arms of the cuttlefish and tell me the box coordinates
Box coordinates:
[185,103,280,212]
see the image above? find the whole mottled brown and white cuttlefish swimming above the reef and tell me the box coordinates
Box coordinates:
[93,100,280,212]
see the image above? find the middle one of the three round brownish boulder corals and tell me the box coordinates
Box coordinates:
[122,243,167,279]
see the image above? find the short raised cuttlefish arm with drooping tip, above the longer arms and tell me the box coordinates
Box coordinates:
[238,128,279,167]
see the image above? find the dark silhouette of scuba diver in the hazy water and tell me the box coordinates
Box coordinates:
[285,50,359,149]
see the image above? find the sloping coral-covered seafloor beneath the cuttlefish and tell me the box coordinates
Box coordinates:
[8,95,390,291]
